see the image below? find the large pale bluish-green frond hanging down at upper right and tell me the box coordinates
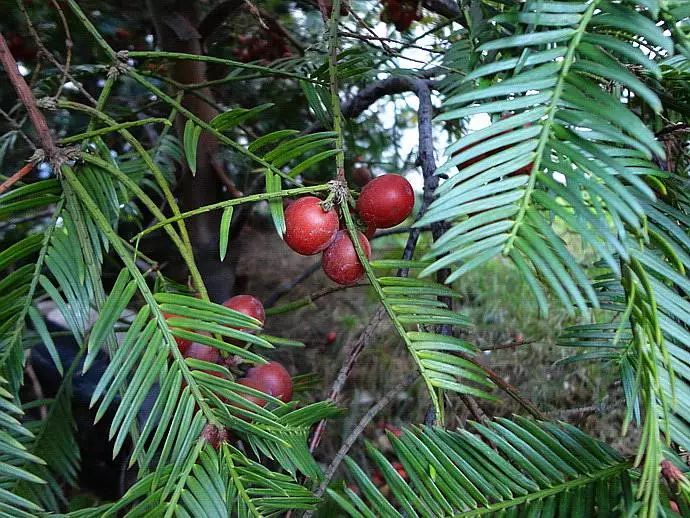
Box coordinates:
[417,1,673,320]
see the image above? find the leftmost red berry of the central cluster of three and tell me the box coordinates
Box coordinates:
[284,196,338,255]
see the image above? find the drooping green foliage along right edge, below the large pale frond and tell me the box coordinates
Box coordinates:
[559,193,690,515]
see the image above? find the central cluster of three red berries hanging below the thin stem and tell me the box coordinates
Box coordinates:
[284,174,414,285]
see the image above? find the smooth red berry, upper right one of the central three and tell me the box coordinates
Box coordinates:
[357,174,414,228]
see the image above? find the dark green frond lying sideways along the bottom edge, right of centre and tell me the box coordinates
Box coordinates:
[329,417,633,517]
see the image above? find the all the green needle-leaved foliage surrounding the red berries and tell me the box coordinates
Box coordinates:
[0,0,690,517]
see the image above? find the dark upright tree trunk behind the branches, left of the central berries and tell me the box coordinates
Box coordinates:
[148,0,236,302]
